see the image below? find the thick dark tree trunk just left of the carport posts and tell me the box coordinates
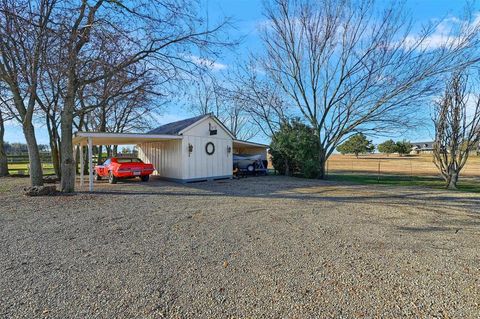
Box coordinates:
[60,90,76,193]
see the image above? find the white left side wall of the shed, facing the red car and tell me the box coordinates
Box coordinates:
[138,140,183,179]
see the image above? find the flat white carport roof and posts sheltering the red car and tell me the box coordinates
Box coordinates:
[73,132,182,192]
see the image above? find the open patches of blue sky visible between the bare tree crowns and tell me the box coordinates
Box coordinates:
[5,0,476,144]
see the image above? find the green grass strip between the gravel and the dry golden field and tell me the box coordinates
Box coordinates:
[328,174,480,193]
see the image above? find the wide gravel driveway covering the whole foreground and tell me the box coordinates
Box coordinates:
[0,177,480,318]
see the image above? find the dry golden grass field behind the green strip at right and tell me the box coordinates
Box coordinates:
[327,154,480,177]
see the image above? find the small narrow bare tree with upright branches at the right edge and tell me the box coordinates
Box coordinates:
[433,72,480,189]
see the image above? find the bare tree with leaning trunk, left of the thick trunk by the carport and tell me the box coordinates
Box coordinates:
[0,0,54,185]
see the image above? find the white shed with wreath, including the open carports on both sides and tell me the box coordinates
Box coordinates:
[74,114,268,189]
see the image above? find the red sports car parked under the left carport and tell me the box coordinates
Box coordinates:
[95,157,154,184]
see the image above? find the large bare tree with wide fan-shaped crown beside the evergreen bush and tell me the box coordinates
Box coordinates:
[261,0,480,178]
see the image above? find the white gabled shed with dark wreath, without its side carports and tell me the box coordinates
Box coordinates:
[138,115,234,182]
